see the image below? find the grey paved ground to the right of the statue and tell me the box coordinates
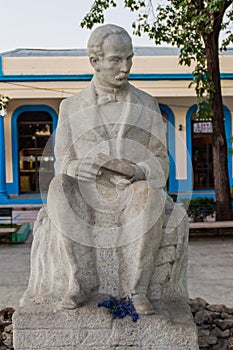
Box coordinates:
[188,237,233,307]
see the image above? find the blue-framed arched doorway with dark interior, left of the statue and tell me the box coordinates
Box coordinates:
[12,106,57,195]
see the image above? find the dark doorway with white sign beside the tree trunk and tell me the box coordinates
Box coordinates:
[192,113,214,190]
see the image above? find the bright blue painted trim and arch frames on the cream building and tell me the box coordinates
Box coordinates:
[0,55,233,202]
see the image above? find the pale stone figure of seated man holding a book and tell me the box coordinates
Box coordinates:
[20,24,187,314]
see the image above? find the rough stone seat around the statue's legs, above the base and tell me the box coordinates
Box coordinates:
[21,196,188,310]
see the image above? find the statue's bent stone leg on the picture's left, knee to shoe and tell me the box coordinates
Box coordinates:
[48,175,99,309]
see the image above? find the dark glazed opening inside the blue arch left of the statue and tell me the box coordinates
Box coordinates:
[17,111,54,193]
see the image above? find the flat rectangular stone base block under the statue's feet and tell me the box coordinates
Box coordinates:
[13,297,199,350]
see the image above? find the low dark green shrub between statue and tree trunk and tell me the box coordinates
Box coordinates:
[181,198,215,222]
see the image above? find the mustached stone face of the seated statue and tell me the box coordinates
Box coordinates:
[96,34,133,88]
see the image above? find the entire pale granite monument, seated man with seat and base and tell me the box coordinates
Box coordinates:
[13,25,197,350]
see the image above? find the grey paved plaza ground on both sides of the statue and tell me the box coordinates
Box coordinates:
[0,211,233,309]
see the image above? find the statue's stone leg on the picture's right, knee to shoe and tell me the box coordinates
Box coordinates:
[118,181,164,314]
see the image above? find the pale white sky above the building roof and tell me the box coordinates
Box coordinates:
[0,0,154,52]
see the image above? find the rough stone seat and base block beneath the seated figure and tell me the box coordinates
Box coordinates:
[13,201,199,350]
